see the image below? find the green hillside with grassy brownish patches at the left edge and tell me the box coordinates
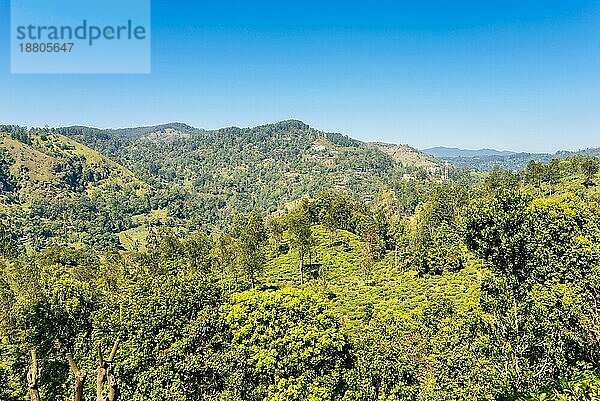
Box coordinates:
[0,128,151,248]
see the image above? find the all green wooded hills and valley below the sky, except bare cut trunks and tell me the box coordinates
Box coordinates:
[0,121,600,401]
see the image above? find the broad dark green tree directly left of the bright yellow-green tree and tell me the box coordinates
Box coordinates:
[93,265,225,401]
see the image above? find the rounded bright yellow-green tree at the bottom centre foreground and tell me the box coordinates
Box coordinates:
[221,288,351,401]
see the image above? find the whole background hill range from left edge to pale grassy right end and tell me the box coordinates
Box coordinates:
[0,121,442,249]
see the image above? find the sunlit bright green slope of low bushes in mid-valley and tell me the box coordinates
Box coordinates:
[265,226,485,324]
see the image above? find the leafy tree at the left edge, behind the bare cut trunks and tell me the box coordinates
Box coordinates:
[0,248,103,400]
